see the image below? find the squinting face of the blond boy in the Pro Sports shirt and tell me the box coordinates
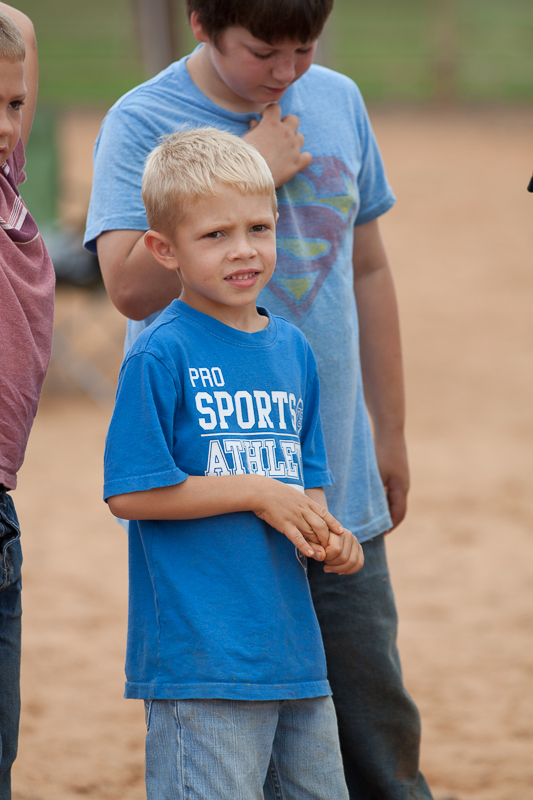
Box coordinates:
[151,186,276,319]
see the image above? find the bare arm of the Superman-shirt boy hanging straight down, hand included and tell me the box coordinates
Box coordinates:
[353,220,409,527]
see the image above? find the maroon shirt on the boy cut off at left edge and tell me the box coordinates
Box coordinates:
[0,140,55,489]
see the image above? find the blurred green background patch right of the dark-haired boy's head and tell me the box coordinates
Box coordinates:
[328,0,533,102]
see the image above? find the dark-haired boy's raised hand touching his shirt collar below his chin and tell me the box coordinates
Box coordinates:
[243,103,312,186]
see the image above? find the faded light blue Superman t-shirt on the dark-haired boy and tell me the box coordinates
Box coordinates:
[85,53,394,541]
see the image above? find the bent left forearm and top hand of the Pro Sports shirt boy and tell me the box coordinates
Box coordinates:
[107,475,344,561]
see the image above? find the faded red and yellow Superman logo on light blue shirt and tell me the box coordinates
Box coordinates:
[268,156,357,318]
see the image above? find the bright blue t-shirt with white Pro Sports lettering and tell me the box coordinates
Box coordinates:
[104,300,332,700]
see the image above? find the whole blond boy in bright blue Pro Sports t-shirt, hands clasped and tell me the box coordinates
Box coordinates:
[104,128,362,800]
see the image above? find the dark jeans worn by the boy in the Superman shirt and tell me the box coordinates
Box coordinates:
[308,535,432,800]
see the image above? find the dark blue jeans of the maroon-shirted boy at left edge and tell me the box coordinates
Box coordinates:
[0,490,22,800]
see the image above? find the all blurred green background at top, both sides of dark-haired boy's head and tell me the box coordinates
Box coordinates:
[12,0,533,105]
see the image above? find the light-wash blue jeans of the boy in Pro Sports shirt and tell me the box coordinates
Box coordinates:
[145,697,348,800]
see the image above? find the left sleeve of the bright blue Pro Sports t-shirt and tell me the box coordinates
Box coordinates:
[104,351,188,499]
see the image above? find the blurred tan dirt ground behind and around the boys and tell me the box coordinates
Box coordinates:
[8,109,533,800]
